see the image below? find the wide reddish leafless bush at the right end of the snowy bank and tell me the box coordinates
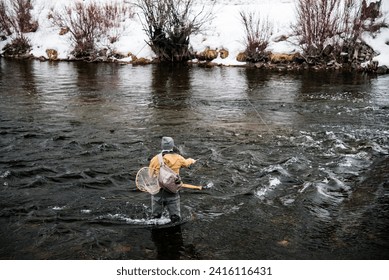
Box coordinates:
[294,0,380,63]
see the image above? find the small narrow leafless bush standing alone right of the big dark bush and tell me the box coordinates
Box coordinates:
[240,11,273,62]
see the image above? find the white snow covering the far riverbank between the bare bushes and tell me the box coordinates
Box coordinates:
[0,0,389,66]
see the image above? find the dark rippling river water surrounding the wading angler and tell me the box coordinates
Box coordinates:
[0,59,389,259]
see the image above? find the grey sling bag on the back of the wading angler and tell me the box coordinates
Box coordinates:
[158,153,182,193]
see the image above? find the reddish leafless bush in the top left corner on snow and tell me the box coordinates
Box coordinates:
[0,0,38,37]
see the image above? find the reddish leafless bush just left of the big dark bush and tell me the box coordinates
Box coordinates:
[51,2,133,57]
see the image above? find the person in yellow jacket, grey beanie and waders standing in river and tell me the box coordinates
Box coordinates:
[149,137,196,223]
